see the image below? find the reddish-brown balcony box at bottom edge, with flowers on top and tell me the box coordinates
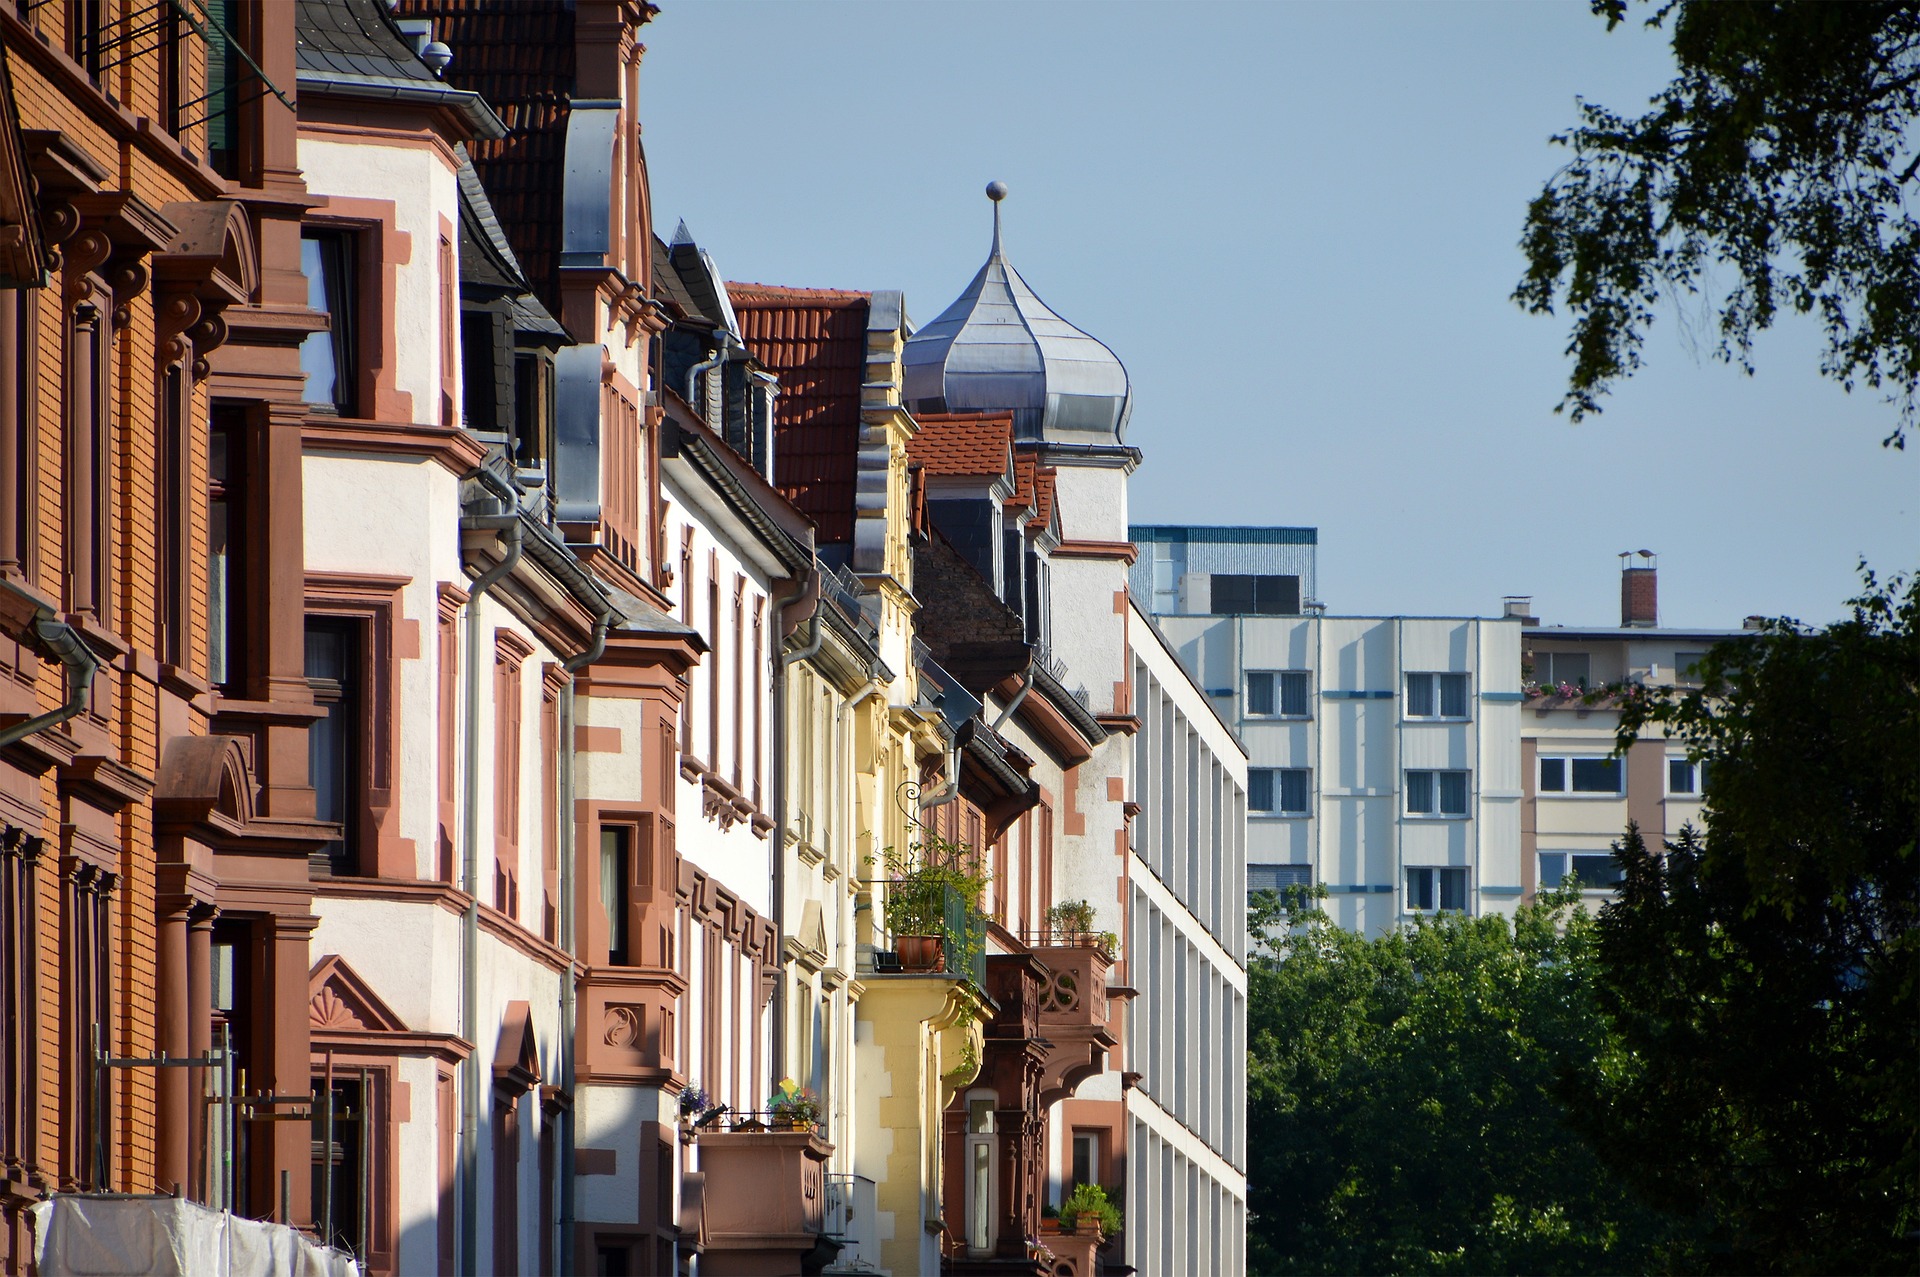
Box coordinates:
[697,1121,833,1277]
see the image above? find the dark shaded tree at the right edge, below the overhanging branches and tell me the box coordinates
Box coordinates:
[1582,574,1920,1273]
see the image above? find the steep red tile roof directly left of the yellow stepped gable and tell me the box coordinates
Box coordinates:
[728,284,870,545]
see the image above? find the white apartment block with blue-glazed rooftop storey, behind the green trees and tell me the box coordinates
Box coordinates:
[1133,528,1526,933]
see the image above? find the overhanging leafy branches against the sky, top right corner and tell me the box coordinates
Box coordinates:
[1513,0,1920,447]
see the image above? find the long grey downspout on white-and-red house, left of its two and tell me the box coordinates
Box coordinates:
[461,467,526,1277]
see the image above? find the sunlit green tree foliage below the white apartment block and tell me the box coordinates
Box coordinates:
[1248,891,1657,1273]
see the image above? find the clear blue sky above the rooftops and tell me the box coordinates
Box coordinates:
[637,0,1920,626]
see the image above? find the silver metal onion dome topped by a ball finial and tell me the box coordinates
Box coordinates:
[904,182,1133,444]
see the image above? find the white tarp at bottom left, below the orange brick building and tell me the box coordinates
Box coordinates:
[33,1194,361,1277]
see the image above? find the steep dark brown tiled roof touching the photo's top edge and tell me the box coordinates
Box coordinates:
[393,0,574,313]
